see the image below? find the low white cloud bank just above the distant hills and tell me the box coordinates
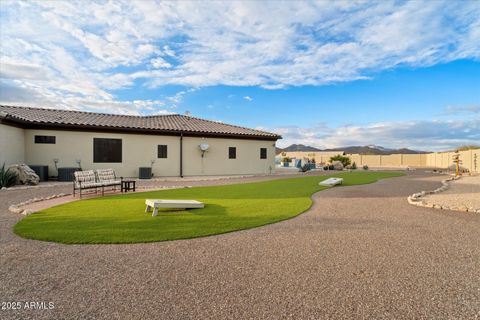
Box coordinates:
[270,118,480,151]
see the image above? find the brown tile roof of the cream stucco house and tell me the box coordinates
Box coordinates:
[0,105,281,140]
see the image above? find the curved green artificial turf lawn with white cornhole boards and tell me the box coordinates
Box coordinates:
[14,172,402,243]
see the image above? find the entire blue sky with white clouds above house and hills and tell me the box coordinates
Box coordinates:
[0,1,480,150]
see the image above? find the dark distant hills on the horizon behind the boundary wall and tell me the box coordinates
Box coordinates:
[276,144,427,155]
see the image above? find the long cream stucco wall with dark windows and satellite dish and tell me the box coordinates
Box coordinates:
[25,129,275,177]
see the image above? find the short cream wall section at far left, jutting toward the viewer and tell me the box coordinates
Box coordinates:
[0,124,25,166]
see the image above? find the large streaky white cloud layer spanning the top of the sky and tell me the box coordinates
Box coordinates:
[0,0,480,110]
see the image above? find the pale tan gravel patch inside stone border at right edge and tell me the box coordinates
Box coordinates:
[423,175,480,210]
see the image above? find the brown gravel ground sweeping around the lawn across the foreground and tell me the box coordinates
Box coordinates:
[0,171,480,319]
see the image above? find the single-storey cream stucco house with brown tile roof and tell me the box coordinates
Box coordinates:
[0,105,281,177]
